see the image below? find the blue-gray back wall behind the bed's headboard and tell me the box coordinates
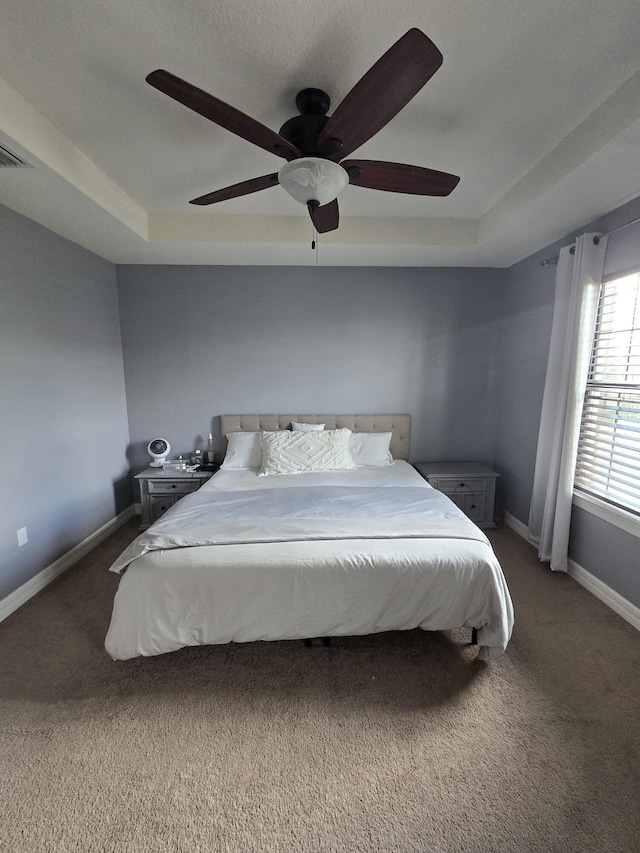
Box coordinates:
[117,266,506,476]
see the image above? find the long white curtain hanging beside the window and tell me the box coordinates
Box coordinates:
[529,234,607,572]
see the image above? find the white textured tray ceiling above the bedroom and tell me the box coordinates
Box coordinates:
[0,0,640,266]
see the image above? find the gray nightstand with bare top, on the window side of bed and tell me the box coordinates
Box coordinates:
[413,462,500,527]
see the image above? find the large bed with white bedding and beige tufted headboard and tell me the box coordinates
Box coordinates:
[105,415,513,660]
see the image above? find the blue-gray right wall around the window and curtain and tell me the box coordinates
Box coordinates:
[496,199,640,607]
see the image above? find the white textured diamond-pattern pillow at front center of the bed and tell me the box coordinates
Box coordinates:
[260,429,356,476]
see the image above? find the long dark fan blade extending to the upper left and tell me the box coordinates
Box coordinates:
[146,69,301,160]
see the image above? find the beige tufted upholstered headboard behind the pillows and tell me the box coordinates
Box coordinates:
[220,415,411,459]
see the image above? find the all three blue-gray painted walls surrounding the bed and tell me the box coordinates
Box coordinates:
[0,186,640,606]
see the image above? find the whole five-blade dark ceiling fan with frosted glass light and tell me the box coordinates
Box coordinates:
[146,28,460,233]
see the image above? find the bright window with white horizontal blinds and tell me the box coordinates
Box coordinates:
[575,273,640,516]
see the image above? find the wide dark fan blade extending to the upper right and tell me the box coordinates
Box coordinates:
[317,28,442,160]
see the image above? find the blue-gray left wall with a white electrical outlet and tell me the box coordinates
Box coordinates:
[0,206,131,598]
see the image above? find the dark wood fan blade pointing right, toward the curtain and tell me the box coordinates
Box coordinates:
[340,160,460,196]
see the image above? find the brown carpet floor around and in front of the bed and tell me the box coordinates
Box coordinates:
[0,520,640,853]
